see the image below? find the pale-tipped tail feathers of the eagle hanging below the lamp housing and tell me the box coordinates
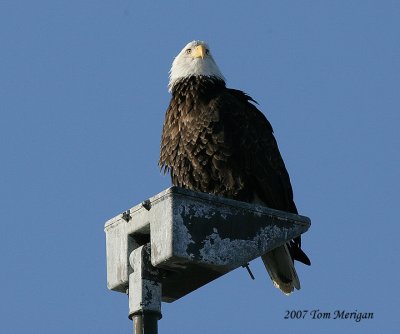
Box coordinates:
[261,244,300,295]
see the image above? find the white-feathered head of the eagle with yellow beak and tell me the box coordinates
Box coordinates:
[168,41,225,92]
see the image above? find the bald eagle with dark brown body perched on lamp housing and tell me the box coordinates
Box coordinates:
[159,41,310,294]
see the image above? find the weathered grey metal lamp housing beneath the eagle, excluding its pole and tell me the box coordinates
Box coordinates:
[105,187,310,302]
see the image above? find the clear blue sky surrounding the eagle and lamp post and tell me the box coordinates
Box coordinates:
[0,0,400,334]
